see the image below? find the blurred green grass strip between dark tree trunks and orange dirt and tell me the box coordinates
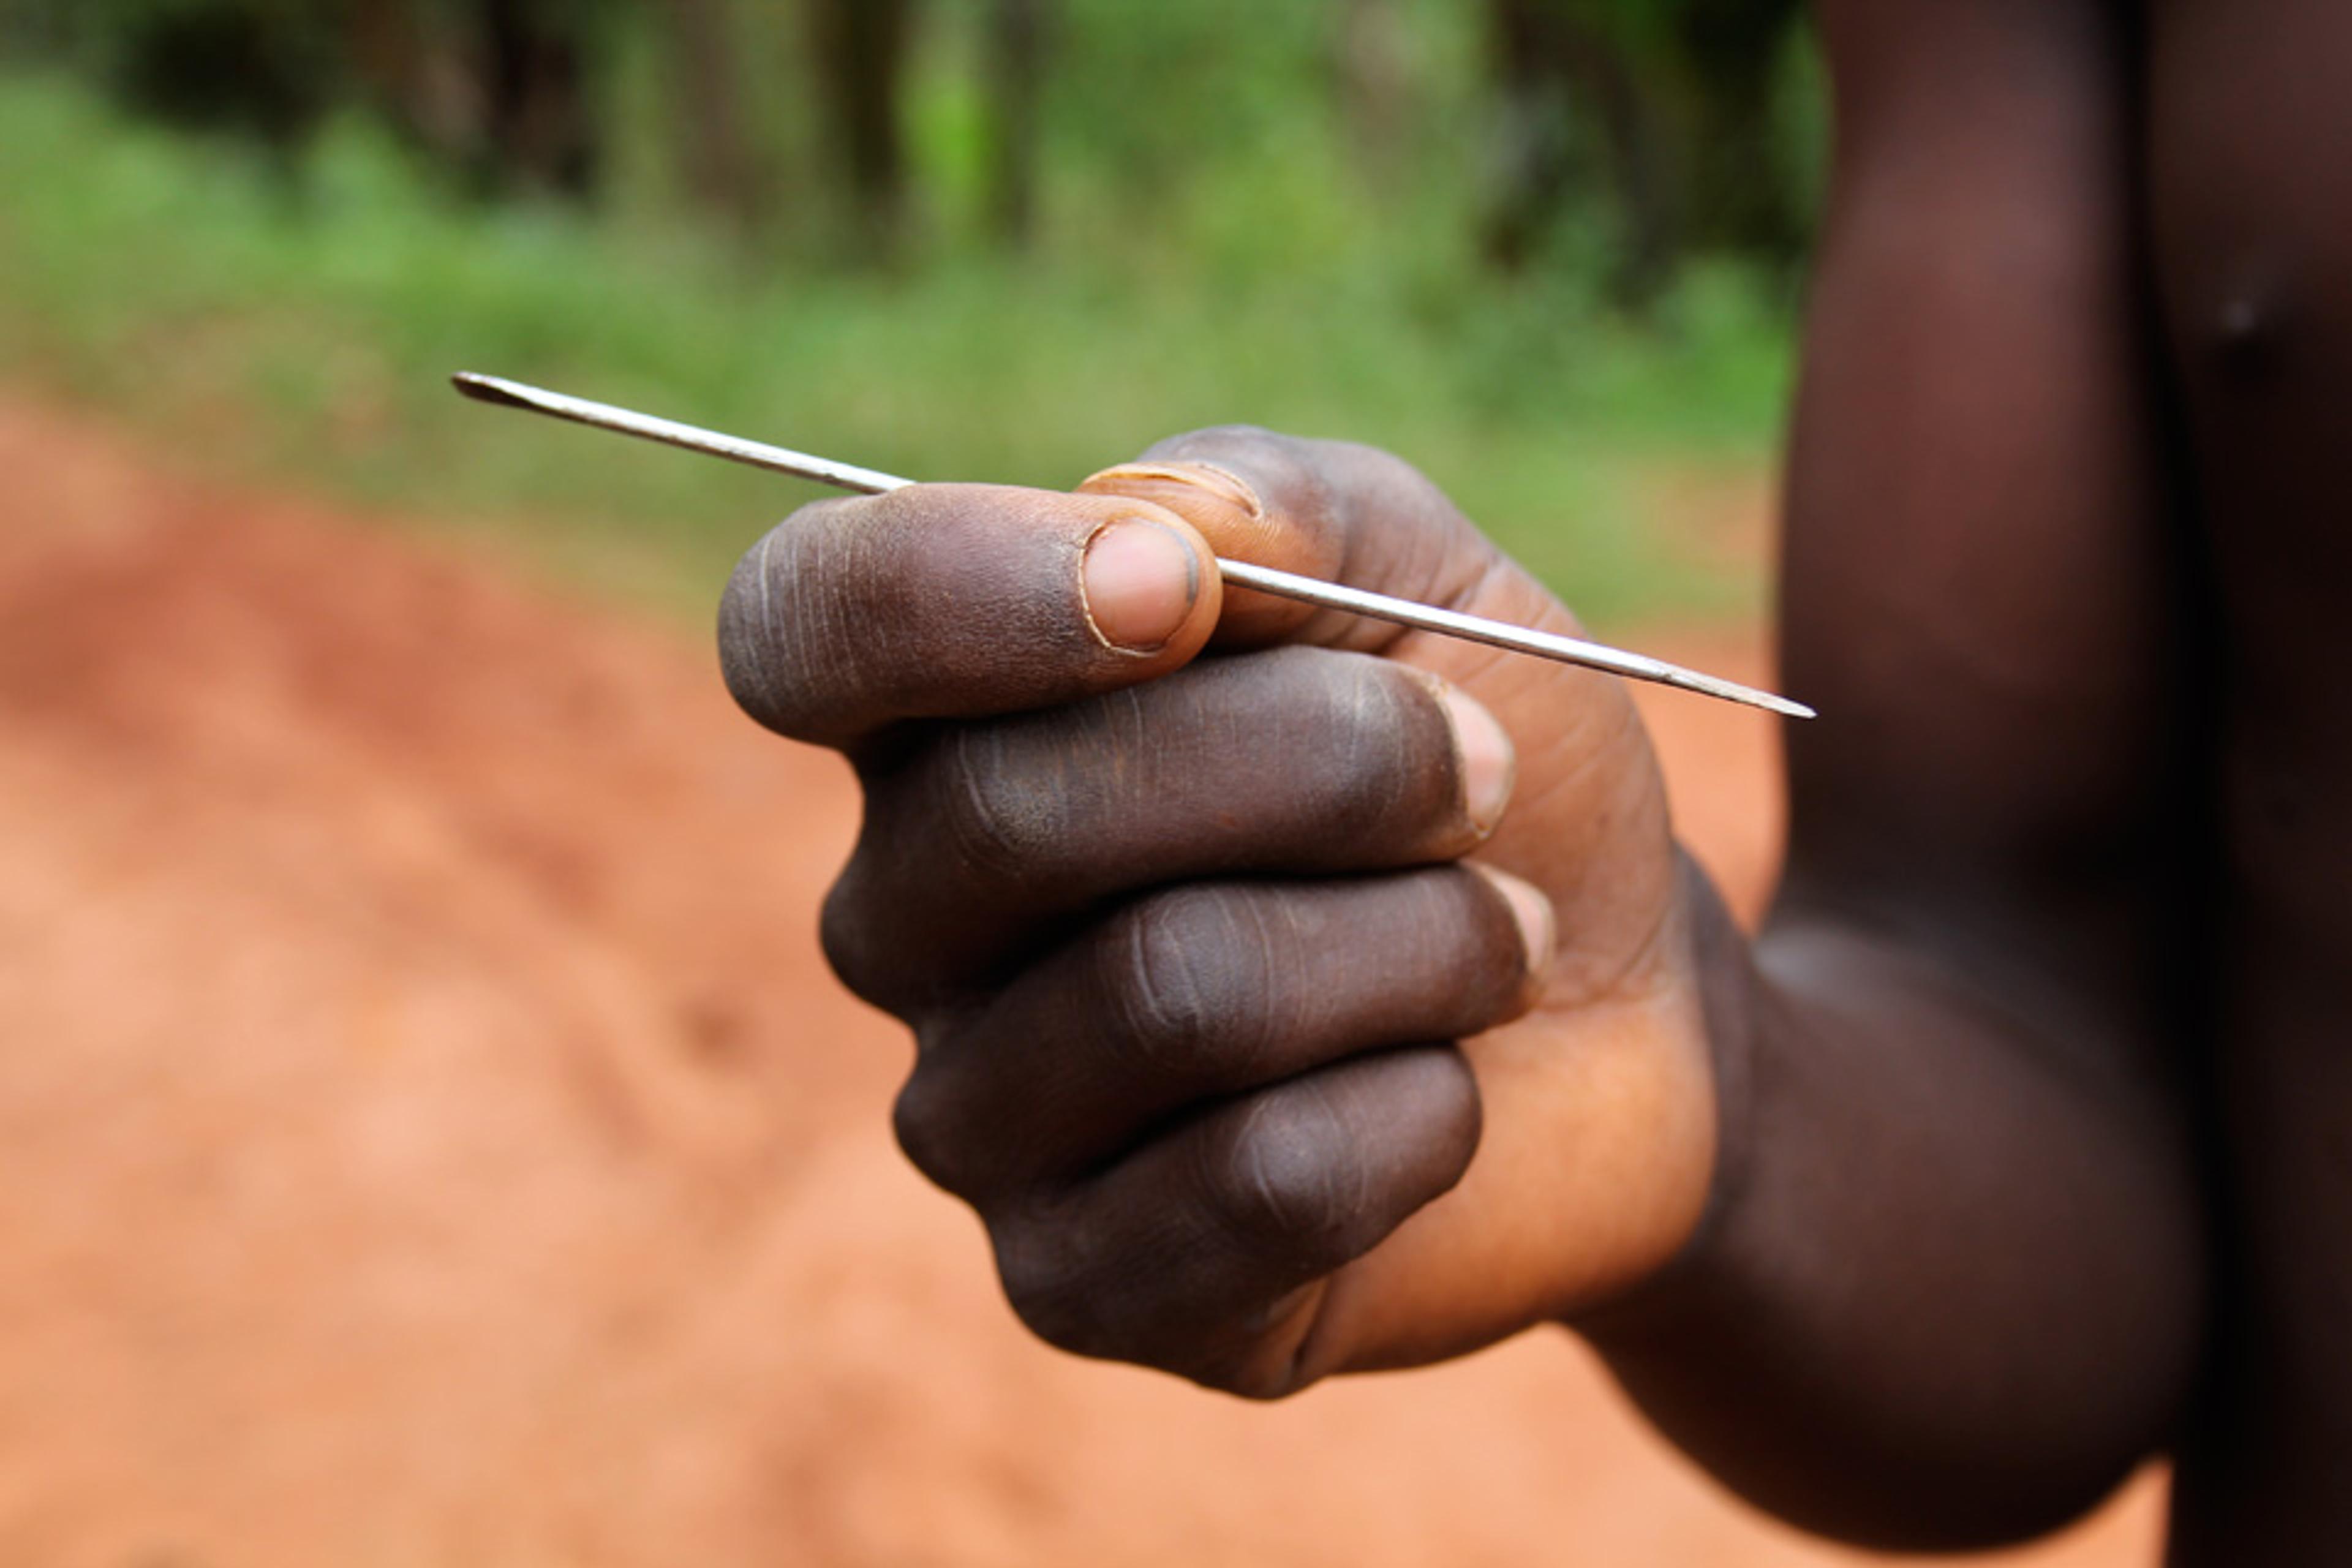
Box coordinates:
[0,75,1787,620]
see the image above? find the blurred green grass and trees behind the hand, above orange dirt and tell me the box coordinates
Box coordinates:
[0,0,1820,618]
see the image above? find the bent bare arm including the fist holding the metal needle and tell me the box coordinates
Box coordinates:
[722,0,2201,1545]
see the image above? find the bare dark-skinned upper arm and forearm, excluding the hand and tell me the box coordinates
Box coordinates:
[1588,0,2201,1545]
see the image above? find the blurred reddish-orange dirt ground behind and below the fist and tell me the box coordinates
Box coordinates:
[0,395,2157,1568]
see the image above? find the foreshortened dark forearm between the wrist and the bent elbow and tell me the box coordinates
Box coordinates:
[1578,865,2201,1547]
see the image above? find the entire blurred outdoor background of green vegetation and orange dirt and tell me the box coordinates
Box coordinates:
[0,0,2157,1568]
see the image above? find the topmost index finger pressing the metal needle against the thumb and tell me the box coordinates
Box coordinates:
[720,484,1223,745]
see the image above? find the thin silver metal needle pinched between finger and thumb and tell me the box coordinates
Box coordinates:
[451,371,1814,719]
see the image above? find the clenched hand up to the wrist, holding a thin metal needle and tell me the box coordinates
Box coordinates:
[720,430,1717,1396]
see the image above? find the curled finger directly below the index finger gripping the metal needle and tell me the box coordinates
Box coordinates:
[826,646,1510,1006]
